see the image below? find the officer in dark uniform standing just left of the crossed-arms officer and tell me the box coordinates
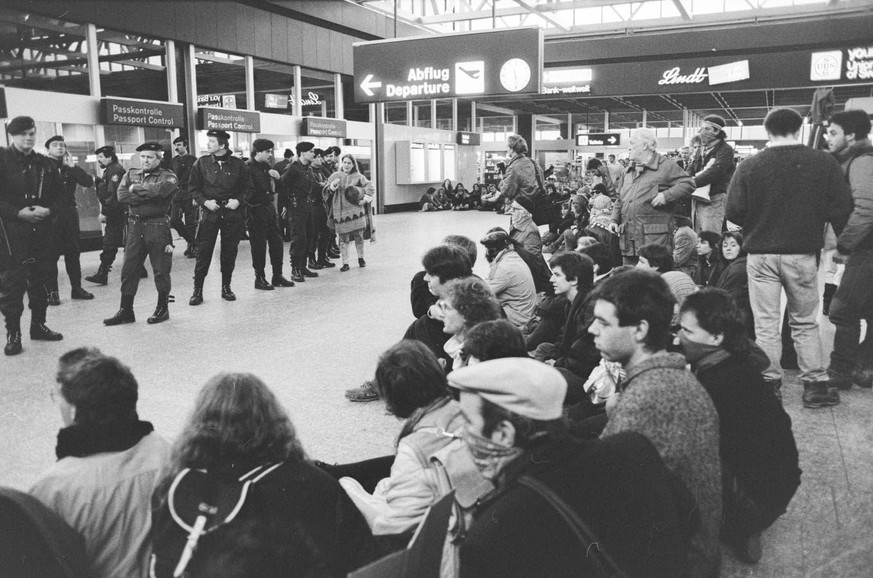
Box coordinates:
[85,146,125,285]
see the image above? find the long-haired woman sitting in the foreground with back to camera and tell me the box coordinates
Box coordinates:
[153,373,376,576]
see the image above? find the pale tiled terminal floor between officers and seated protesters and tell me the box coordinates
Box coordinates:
[0,212,873,577]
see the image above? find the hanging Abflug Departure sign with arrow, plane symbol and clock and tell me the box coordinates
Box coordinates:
[354,27,543,103]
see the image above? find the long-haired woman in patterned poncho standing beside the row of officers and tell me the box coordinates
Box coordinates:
[324,154,376,272]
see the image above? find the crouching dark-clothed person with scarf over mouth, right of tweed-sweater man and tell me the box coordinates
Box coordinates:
[679,288,801,562]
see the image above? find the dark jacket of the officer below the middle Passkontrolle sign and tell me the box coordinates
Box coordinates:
[188,153,252,205]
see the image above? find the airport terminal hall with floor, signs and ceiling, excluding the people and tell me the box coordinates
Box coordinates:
[0,0,873,578]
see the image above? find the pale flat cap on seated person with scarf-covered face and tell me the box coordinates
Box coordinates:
[448,357,567,420]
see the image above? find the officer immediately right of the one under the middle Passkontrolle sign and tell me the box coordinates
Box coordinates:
[246,138,294,291]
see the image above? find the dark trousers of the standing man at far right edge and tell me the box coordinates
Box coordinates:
[828,251,873,377]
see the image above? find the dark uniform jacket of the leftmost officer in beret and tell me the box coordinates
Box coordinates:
[0,147,63,263]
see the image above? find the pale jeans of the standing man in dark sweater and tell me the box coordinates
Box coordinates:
[746,253,827,382]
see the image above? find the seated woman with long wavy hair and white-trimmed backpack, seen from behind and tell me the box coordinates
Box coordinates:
[151,373,376,578]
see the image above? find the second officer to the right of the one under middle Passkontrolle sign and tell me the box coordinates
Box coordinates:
[279,141,321,283]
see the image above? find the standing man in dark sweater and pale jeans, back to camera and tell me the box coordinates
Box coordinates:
[727,108,852,409]
